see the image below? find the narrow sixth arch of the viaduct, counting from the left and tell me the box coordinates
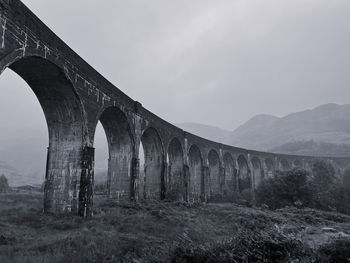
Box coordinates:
[208,149,221,198]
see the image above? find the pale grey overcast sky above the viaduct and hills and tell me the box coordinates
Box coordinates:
[0,0,350,130]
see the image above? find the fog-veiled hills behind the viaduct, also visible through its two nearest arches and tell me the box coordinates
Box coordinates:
[0,104,350,185]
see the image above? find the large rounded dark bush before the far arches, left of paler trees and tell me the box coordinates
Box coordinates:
[256,169,311,209]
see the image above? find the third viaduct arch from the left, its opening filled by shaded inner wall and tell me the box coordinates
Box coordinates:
[139,127,164,199]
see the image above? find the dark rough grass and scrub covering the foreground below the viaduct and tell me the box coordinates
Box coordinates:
[0,192,350,262]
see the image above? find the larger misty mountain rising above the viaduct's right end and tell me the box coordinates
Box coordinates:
[226,103,350,156]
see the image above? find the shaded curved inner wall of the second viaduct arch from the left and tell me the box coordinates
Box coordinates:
[99,106,135,200]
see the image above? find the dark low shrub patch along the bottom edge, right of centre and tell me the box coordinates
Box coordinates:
[169,230,309,263]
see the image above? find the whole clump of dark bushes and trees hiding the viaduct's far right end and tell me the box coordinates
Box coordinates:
[256,161,350,215]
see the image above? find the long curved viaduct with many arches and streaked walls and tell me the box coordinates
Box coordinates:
[0,0,349,216]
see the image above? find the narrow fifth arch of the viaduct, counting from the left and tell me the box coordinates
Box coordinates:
[186,144,204,201]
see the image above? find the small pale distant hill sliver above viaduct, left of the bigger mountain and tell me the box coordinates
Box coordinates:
[174,122,231,142]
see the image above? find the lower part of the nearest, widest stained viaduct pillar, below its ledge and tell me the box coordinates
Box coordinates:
[44,143,94,216]
